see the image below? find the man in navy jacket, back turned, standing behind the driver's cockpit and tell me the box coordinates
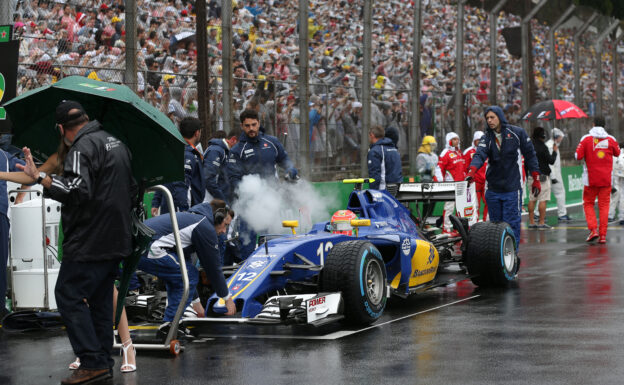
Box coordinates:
[367,126,403,190]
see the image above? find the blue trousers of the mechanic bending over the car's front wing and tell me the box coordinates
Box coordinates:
[138,253,199,322]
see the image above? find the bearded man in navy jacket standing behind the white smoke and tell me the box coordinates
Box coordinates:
[227,110,297,260]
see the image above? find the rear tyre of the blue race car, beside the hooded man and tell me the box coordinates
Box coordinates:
[466,222,520,287]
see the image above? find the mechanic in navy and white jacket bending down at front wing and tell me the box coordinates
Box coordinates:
[138,199,236,334]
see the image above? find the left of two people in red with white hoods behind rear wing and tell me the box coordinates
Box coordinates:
[436,132,466,233]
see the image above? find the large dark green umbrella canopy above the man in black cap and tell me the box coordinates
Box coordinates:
[4,76,186,187]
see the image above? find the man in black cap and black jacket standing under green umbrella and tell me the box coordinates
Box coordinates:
[24,101,137,384]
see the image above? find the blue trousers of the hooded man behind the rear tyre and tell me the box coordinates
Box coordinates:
[485,190,522,251]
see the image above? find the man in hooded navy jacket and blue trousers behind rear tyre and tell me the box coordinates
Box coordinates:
[466,106,542,250]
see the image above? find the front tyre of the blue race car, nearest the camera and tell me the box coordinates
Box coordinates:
[320,241,387,325]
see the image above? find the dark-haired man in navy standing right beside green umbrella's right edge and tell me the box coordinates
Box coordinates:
[152,117,206,216]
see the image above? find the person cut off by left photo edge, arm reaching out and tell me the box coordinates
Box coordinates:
[0,150,24,321]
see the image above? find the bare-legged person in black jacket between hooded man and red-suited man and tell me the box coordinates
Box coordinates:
[527,127,557,230]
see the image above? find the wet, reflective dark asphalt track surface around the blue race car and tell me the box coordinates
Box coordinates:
[0,221,624,384]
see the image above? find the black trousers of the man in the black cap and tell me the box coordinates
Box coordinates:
[54,259,119,369]
